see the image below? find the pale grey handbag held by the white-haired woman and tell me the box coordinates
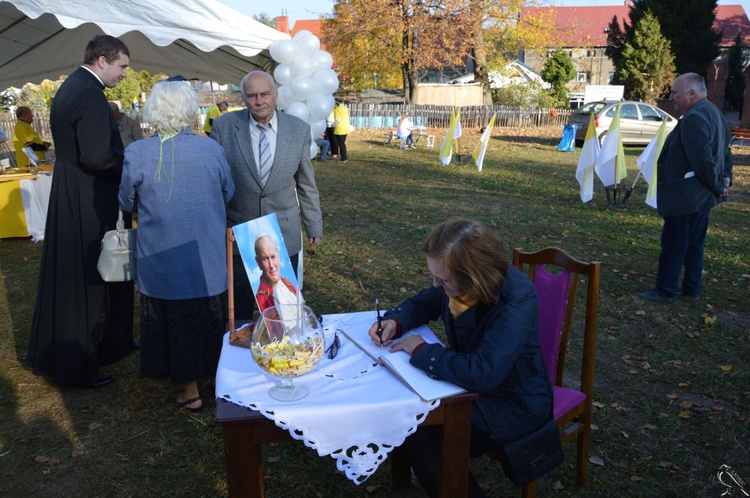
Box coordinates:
[96,211,136,282]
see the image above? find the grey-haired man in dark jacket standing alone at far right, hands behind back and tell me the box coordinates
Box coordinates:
[638,73,733,301]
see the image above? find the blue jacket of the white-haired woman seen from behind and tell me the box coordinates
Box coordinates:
[119,130,234,300]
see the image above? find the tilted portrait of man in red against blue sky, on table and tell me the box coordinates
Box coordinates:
[232,213,305,312]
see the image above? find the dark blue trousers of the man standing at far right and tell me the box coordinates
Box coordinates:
[656,209,711,297]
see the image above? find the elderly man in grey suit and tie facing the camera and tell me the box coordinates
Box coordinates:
[211,71,323,318]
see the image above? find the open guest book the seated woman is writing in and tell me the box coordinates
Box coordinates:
[341,313,466,401]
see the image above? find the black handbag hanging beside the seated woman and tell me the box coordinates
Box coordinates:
[477,403,563,487]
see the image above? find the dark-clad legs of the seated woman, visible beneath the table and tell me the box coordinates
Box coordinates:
[404,426,492,498]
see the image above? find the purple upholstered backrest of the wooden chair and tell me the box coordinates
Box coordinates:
[534,265,570,384]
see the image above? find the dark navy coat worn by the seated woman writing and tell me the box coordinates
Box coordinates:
[386,267,552,440]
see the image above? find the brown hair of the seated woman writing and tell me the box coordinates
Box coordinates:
[422,218,510,304]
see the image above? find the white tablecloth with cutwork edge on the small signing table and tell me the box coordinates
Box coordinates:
[216,312,440,484]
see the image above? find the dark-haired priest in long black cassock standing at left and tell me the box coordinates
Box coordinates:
[25,35,133,387]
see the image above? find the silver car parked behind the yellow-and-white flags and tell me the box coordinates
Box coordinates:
[568,100,677,147]
